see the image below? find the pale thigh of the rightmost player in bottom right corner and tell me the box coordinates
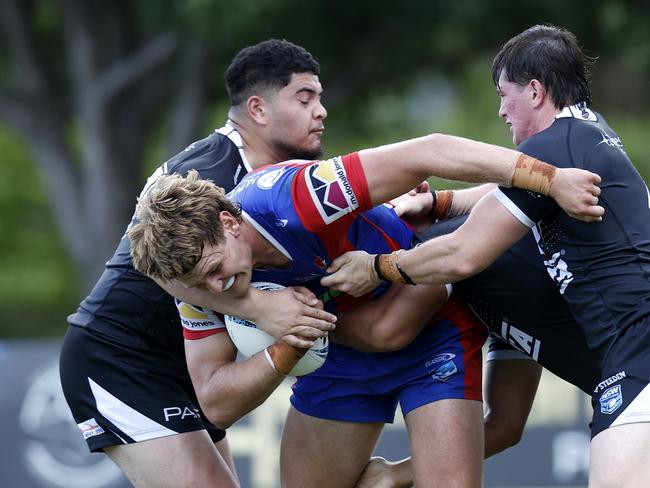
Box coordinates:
[589,422,650,488]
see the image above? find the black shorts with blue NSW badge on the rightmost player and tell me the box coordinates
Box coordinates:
[590,319,650,437]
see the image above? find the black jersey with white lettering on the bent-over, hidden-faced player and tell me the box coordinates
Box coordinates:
[418,216,600,394]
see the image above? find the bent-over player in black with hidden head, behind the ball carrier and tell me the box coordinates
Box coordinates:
[346,216,601,488]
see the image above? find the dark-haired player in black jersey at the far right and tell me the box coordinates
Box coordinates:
[328,26,650,487]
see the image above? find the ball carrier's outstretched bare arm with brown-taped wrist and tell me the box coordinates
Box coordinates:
[359,134,604,221]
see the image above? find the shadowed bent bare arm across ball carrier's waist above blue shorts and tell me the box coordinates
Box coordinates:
[330,283,447,352]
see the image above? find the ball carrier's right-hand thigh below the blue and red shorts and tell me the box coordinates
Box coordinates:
[406,399,484,488]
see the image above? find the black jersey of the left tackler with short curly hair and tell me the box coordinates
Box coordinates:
[68,123,250,346]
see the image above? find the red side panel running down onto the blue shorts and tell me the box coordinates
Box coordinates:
[430,297,487,401]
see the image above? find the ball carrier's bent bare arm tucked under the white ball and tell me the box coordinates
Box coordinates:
[185,333,284,429]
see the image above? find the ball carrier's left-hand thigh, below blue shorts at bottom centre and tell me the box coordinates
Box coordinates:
[280,407,383,488]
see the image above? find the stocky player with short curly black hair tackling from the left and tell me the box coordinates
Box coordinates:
[60,40,335,487]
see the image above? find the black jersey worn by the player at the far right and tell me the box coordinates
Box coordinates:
[495,104,650,358]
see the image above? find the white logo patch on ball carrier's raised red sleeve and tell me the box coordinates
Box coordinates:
[305,158,359,224]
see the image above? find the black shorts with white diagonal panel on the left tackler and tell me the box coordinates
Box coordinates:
[59,325,225,452]
